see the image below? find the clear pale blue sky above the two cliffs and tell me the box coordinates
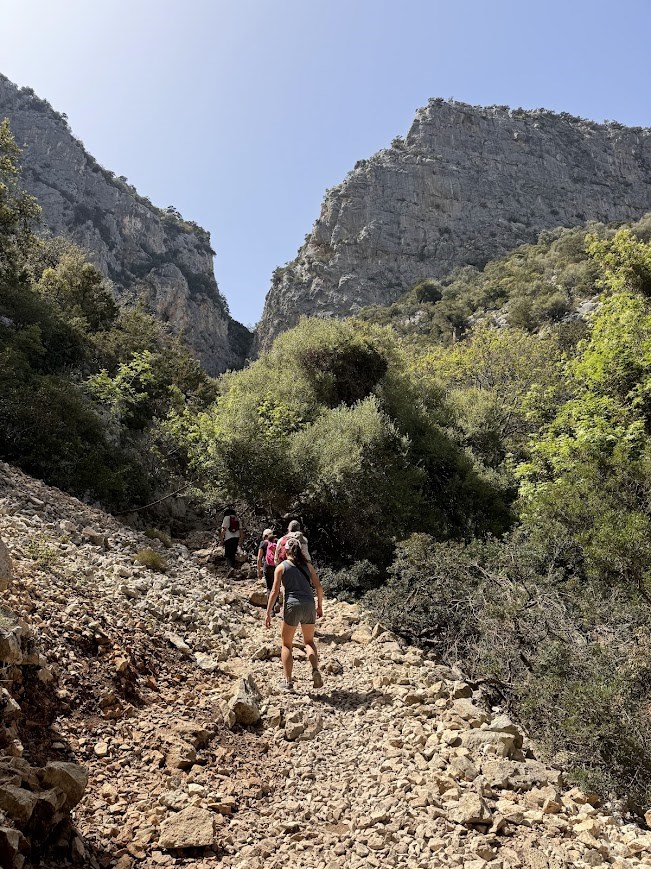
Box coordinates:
[0,0,651,324]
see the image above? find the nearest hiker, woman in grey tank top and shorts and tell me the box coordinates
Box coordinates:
[265,537,323,692]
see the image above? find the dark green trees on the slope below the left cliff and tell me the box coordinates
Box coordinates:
[0,121,214,510]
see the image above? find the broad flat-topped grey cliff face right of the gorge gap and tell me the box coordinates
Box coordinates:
[257,99,651,349]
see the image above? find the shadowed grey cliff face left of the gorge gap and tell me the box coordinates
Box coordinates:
[0,76,251,374]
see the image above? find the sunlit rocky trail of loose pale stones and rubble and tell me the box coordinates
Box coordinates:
[0,464,651,869]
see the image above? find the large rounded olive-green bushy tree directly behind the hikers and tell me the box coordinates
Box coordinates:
[170,320,510,563]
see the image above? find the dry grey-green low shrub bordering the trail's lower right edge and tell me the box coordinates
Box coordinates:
[367,529,651,810]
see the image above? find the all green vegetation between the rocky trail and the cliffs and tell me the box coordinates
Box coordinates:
[0,112,651,807]
